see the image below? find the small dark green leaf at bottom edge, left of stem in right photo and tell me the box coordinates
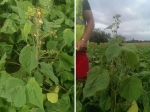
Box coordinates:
[100,94,111,111]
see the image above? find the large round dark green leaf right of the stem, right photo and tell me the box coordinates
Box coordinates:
[119,77,143,101]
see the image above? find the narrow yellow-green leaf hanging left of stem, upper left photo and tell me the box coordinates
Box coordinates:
[22,23,31,42]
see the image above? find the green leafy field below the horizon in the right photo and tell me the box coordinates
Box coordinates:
[77,38,150,112]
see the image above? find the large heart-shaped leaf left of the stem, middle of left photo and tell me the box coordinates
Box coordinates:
[19,46,38,74]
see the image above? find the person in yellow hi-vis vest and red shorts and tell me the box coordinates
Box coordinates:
[76,0,94,82]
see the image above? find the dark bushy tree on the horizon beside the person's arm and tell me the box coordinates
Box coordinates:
[89,28,111,44]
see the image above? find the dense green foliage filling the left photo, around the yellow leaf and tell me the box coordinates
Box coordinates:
[0,0,74,112]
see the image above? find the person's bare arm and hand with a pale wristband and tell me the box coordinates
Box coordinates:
[77,10,94,50]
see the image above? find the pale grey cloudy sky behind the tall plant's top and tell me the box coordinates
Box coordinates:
[88,0,150,40]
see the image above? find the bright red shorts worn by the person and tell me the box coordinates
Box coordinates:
[76,49,89,78]
